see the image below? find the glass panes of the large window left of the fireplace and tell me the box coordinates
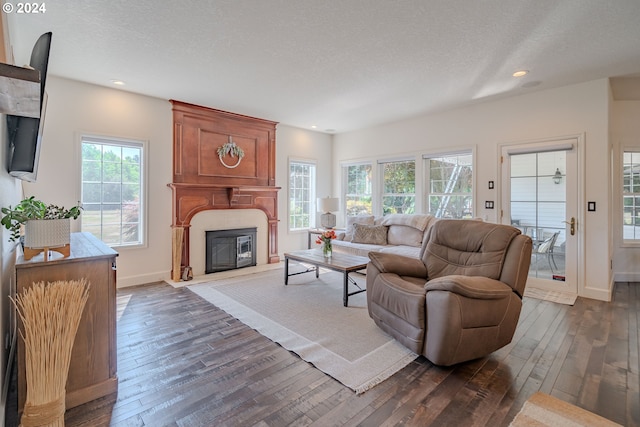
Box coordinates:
[80,137,146,246]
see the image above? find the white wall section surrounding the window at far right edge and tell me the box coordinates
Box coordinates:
[611,101,640,282]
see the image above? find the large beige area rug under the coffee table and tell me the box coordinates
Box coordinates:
[188,268,418,393]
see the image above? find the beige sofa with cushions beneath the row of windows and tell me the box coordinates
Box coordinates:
[332,214,436,258]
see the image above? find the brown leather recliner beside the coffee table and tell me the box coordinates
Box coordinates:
[367,220,532,366]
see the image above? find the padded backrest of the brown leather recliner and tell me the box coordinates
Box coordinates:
[421,219,528,287]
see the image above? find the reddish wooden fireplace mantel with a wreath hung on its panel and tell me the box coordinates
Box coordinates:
[168,100,280,280]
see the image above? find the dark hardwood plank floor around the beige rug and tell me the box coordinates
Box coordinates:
[7,283,640,427]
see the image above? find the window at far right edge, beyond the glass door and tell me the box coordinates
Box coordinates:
[622,151,640,240]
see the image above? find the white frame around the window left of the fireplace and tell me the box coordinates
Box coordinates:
[77,133,149,250]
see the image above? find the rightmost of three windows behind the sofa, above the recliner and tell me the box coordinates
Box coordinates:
[425,151,473,218]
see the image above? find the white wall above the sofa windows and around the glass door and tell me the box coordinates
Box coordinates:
[333,79,612,300]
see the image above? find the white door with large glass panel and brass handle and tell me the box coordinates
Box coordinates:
[502,138,579,294]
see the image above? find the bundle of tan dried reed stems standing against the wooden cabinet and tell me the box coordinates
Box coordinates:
[14,279,89,427]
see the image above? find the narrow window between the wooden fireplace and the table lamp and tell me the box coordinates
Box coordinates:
[289,160,316,231]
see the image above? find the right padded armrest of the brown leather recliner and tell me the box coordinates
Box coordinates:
[424,274,513,299]
